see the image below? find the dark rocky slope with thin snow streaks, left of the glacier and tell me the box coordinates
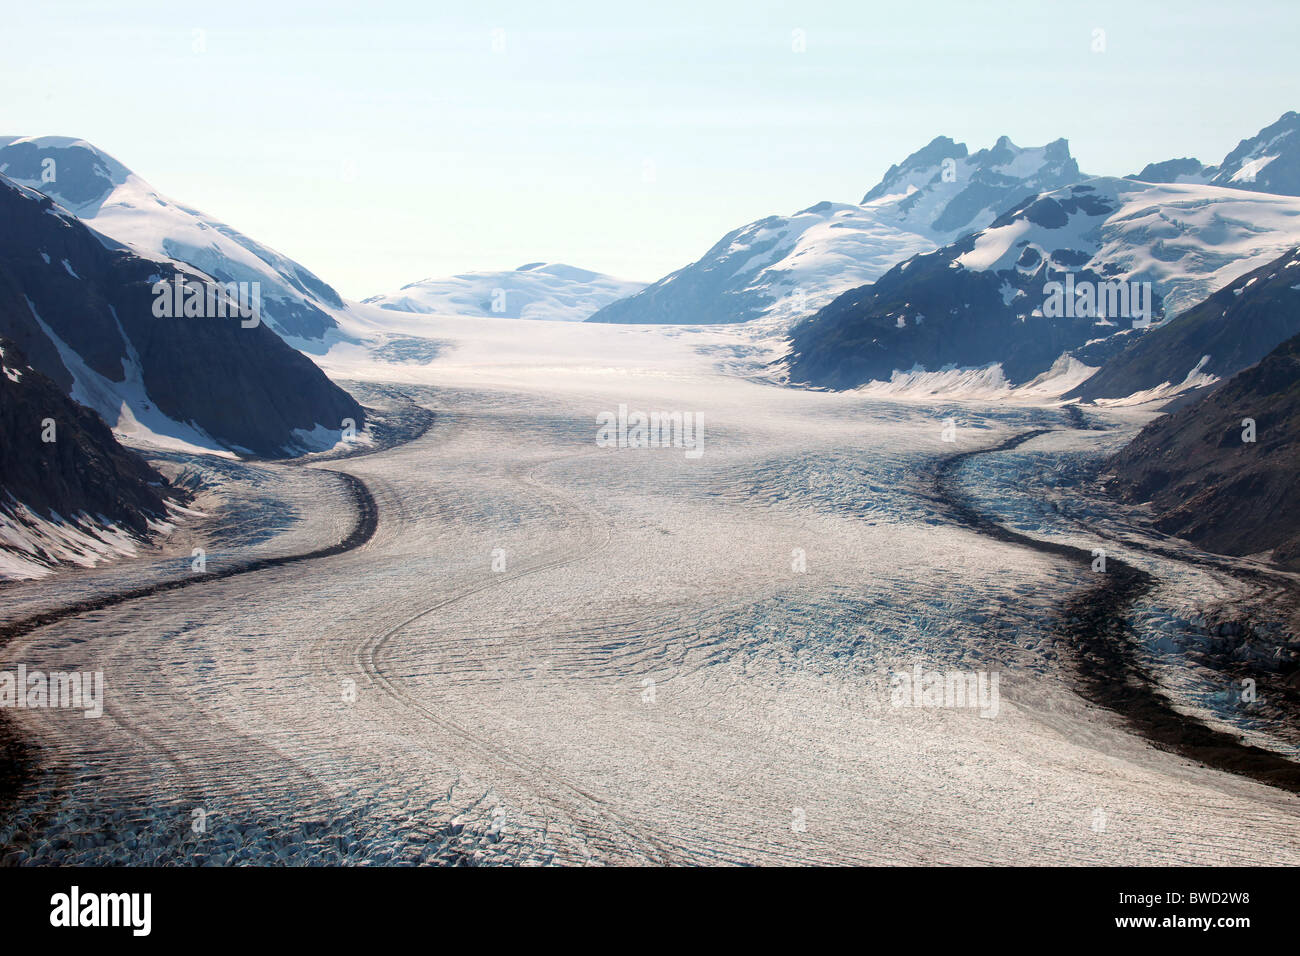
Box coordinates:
[0,174,364,457]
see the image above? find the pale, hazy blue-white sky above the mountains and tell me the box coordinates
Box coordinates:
[0,0,1300,299]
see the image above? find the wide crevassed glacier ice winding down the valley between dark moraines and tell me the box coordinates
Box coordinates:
[0,316,1300,865]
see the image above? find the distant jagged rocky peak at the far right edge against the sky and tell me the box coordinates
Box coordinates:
[1128,112,1300,196]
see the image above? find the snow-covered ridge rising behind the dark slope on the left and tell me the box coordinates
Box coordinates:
[0,137,347,352]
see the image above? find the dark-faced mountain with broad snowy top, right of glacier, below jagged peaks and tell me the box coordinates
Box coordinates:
[788,178,1300,388]
